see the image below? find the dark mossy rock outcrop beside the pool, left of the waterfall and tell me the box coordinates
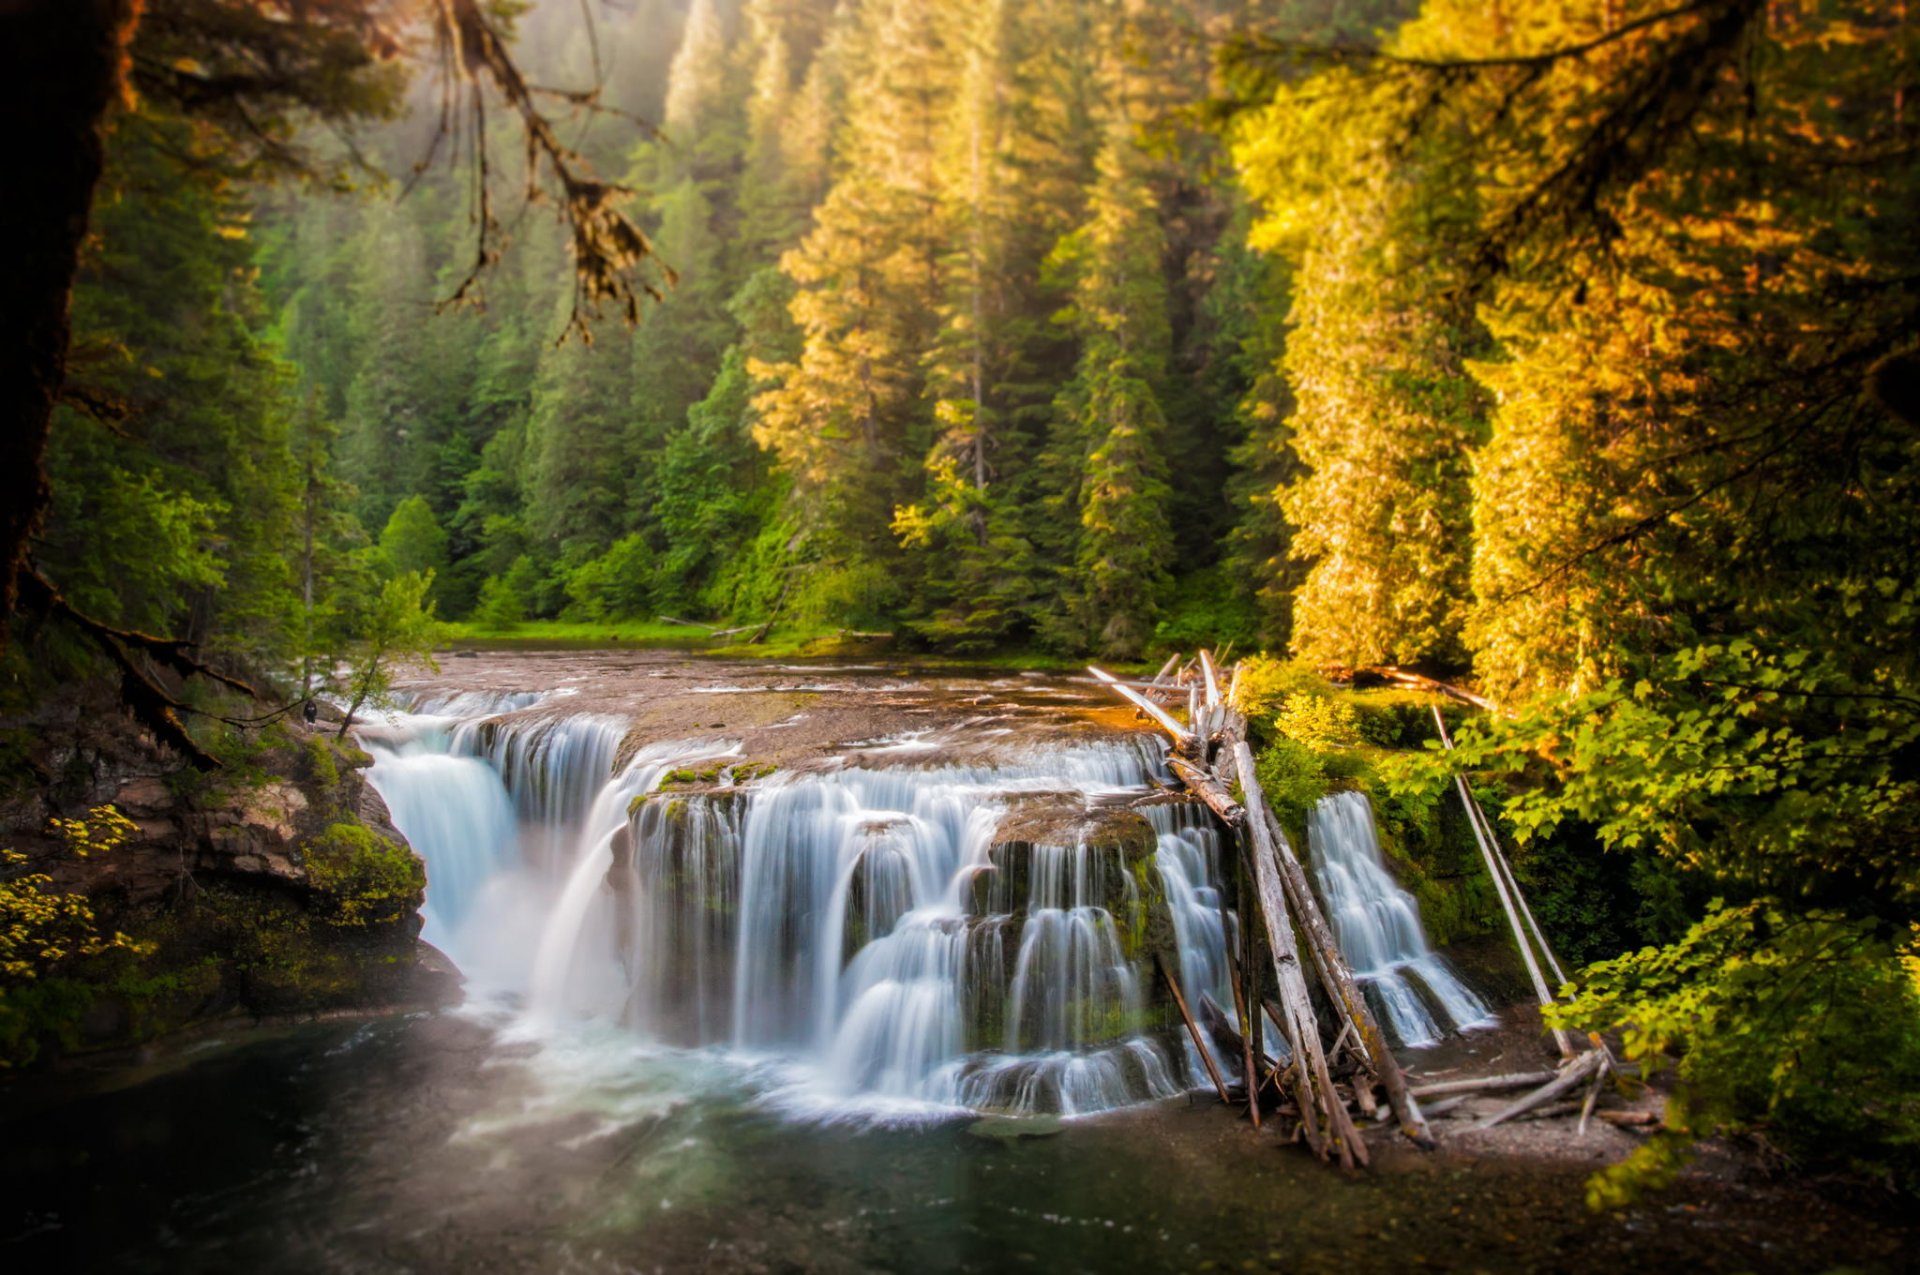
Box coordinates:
[0,691,457,1066]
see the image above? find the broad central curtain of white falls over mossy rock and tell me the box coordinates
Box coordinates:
[587,741,1181,1114]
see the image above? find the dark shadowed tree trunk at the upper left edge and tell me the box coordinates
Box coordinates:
[0,0,140,649]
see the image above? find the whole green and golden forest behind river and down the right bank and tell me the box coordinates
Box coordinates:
[15,0,1920,1205]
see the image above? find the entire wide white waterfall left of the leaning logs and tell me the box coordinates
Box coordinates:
[363,697,1482,1116]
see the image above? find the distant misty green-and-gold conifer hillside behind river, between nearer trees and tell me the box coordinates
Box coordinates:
[265,0,1394,657]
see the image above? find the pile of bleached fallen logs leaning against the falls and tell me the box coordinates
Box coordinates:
[1089,651,1615,1167]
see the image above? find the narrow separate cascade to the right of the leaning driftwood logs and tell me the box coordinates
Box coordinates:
[1308,793,1488,1046]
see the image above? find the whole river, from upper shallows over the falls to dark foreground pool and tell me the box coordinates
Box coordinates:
[0,651,1910,1271]
